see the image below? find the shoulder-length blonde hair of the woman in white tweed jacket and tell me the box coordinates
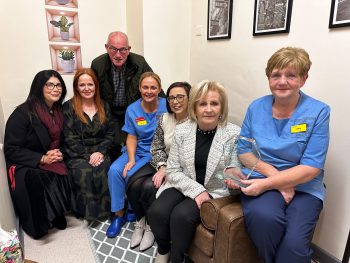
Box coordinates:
[188,80,228,126]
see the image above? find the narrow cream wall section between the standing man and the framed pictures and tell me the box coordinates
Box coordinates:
[143,0,192,90]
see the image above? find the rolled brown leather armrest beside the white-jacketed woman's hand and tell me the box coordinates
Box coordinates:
[200,195,239,230]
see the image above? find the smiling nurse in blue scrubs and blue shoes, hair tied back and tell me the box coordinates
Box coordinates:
[106,72,167,238]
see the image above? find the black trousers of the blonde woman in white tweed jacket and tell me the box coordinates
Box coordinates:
[148,188,200,263]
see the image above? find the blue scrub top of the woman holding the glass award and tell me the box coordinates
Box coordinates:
[238,92,330,200]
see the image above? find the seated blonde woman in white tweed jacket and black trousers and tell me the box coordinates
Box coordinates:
[148,81,240,263]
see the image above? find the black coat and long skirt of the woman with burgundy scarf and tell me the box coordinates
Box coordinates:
[4,104,71,238]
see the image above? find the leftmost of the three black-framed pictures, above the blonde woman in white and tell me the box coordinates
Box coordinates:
[207,0,233,40]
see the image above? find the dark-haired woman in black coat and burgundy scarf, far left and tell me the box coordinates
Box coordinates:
[4,70,71,239]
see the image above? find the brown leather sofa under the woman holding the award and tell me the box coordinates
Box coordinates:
[188,195,263,263]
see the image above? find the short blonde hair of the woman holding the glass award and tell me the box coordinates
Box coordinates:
[265,47,312,78]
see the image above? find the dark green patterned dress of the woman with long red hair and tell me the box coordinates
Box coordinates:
[63,100,115,220]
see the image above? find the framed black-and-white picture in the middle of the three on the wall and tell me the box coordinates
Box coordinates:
[253,0,293,36]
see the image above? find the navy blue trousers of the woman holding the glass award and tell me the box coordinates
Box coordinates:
[241,190,323,263]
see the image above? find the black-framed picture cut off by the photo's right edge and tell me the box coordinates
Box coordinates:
[329,0,350,28]
